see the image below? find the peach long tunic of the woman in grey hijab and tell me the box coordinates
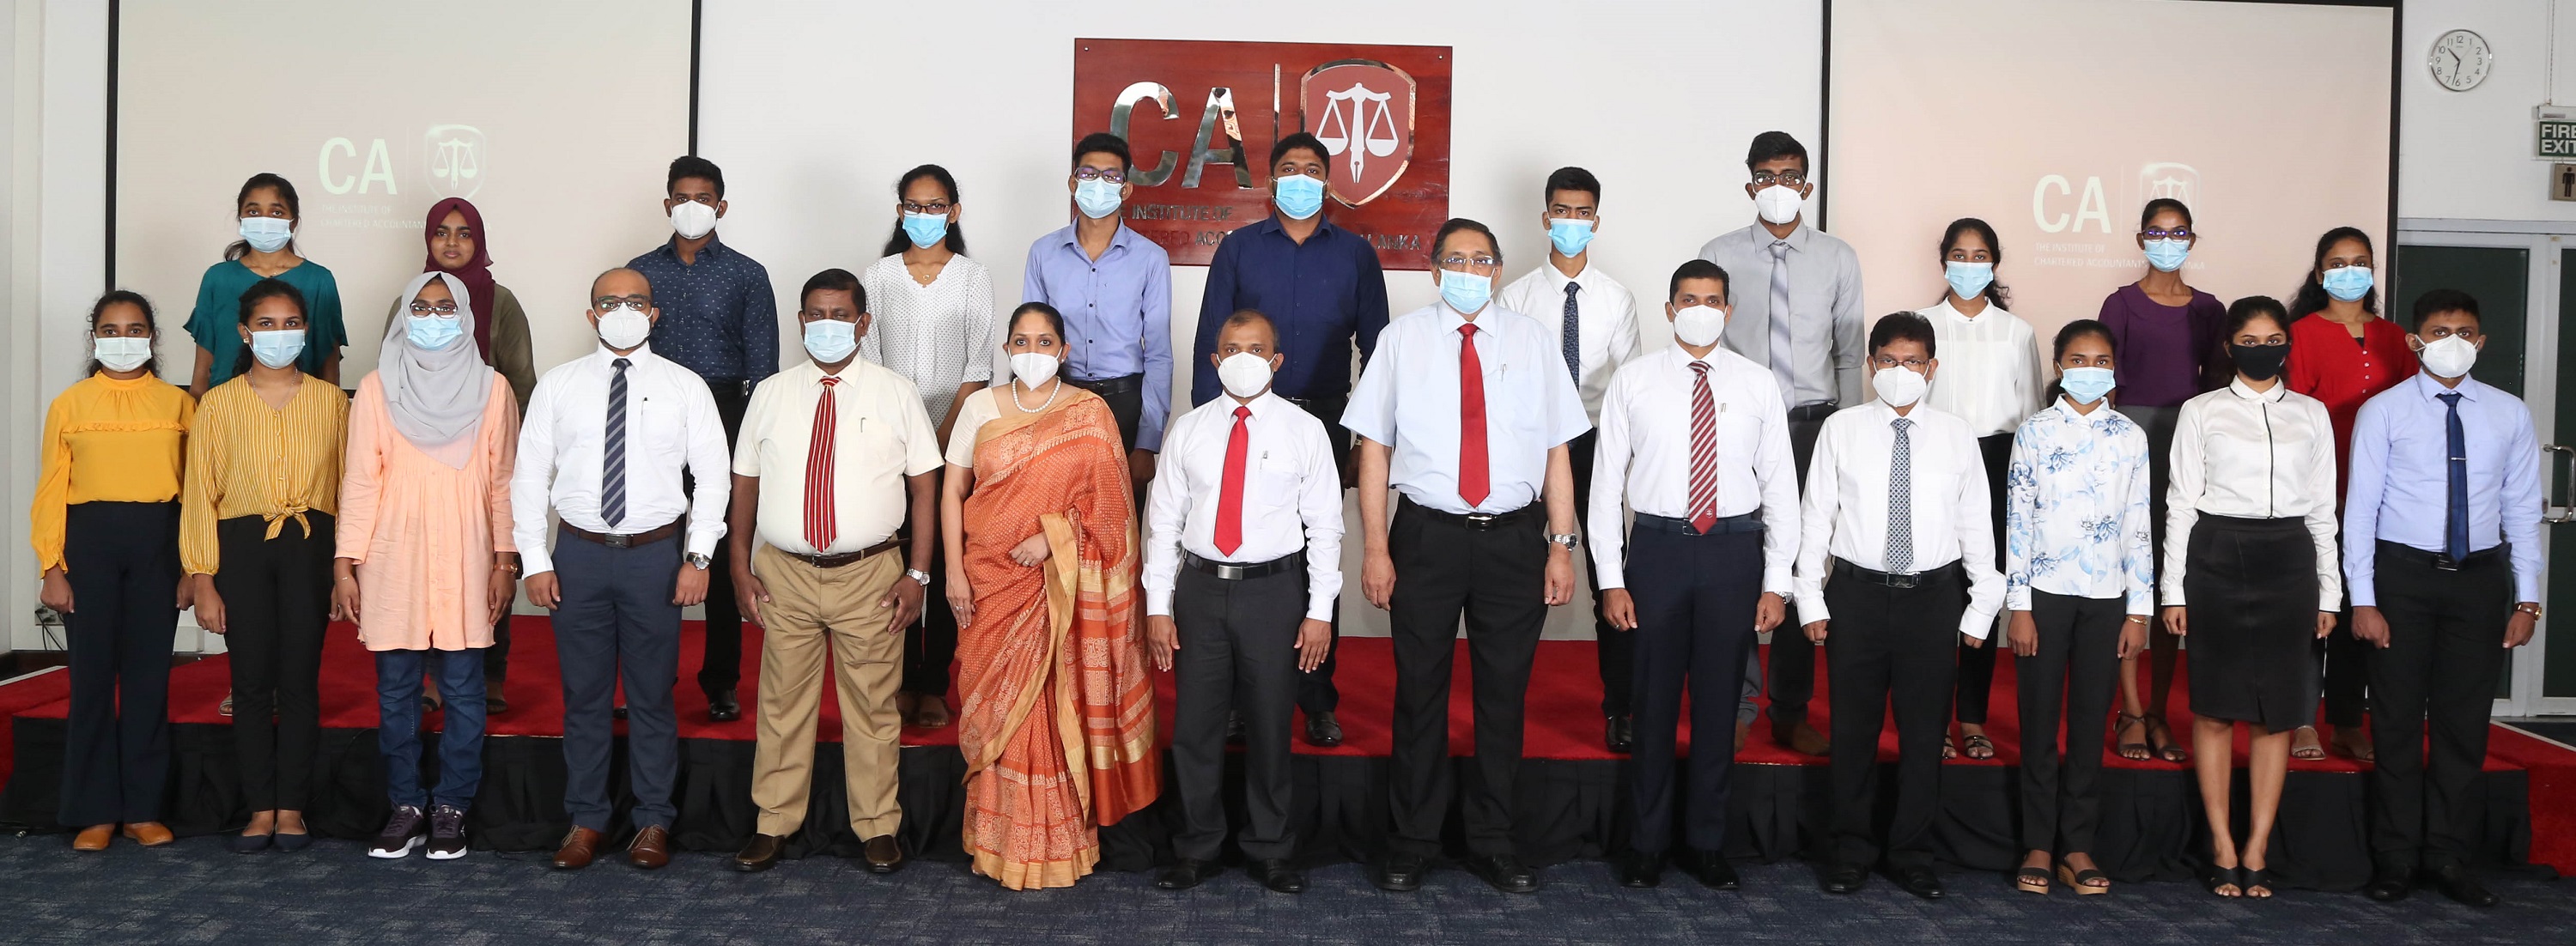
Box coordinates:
[337,373,518,650]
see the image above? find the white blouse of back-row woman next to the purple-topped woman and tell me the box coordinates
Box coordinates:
[1914,296,2048,435]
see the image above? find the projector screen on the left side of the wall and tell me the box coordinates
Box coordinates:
[113,0,690,386]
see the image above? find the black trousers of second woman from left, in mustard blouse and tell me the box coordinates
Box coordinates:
[214,513,332,812]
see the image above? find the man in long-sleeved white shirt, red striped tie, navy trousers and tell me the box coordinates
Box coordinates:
[1589,260,1798,889]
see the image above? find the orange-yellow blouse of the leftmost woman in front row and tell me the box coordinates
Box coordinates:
[28,373,196,573]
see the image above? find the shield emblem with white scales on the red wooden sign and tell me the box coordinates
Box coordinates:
[1298,59,1414,206]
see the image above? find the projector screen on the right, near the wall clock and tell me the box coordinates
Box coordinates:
[1821,0,2396,343]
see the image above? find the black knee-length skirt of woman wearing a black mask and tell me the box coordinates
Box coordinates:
[2182,513,2316,732]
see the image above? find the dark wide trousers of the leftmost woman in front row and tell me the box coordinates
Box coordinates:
[57,503,180,828]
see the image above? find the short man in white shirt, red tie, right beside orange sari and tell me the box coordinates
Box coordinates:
[1144,309,1342,894]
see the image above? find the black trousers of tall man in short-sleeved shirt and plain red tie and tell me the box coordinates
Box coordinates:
[1386,500,1548,856]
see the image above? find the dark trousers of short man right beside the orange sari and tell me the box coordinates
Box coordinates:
[1172,565,1306,861]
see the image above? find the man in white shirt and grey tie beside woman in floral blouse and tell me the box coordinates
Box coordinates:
[1795,312,2004,900]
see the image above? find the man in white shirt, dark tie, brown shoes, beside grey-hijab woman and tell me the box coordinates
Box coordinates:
[510,268,729,869]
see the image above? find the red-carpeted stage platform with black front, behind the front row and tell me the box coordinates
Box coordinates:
[0,616,2576,889]
